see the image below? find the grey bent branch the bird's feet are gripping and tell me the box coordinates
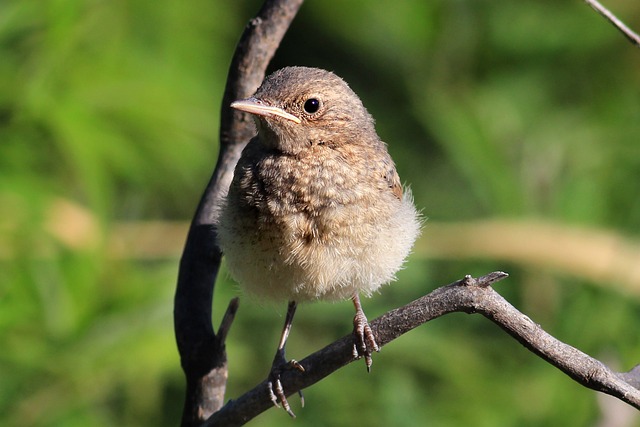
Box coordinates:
[203,272,640,427]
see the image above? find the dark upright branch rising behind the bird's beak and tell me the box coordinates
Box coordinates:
[174,0,302,426]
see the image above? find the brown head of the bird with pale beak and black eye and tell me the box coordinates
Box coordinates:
[231,67,377,155]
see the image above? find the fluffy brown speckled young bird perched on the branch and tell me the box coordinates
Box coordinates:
[218,67,420,416]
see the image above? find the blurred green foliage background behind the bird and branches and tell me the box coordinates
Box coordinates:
[0,0,640,427]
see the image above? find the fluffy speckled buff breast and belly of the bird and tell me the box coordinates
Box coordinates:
[219,140,419,300]
